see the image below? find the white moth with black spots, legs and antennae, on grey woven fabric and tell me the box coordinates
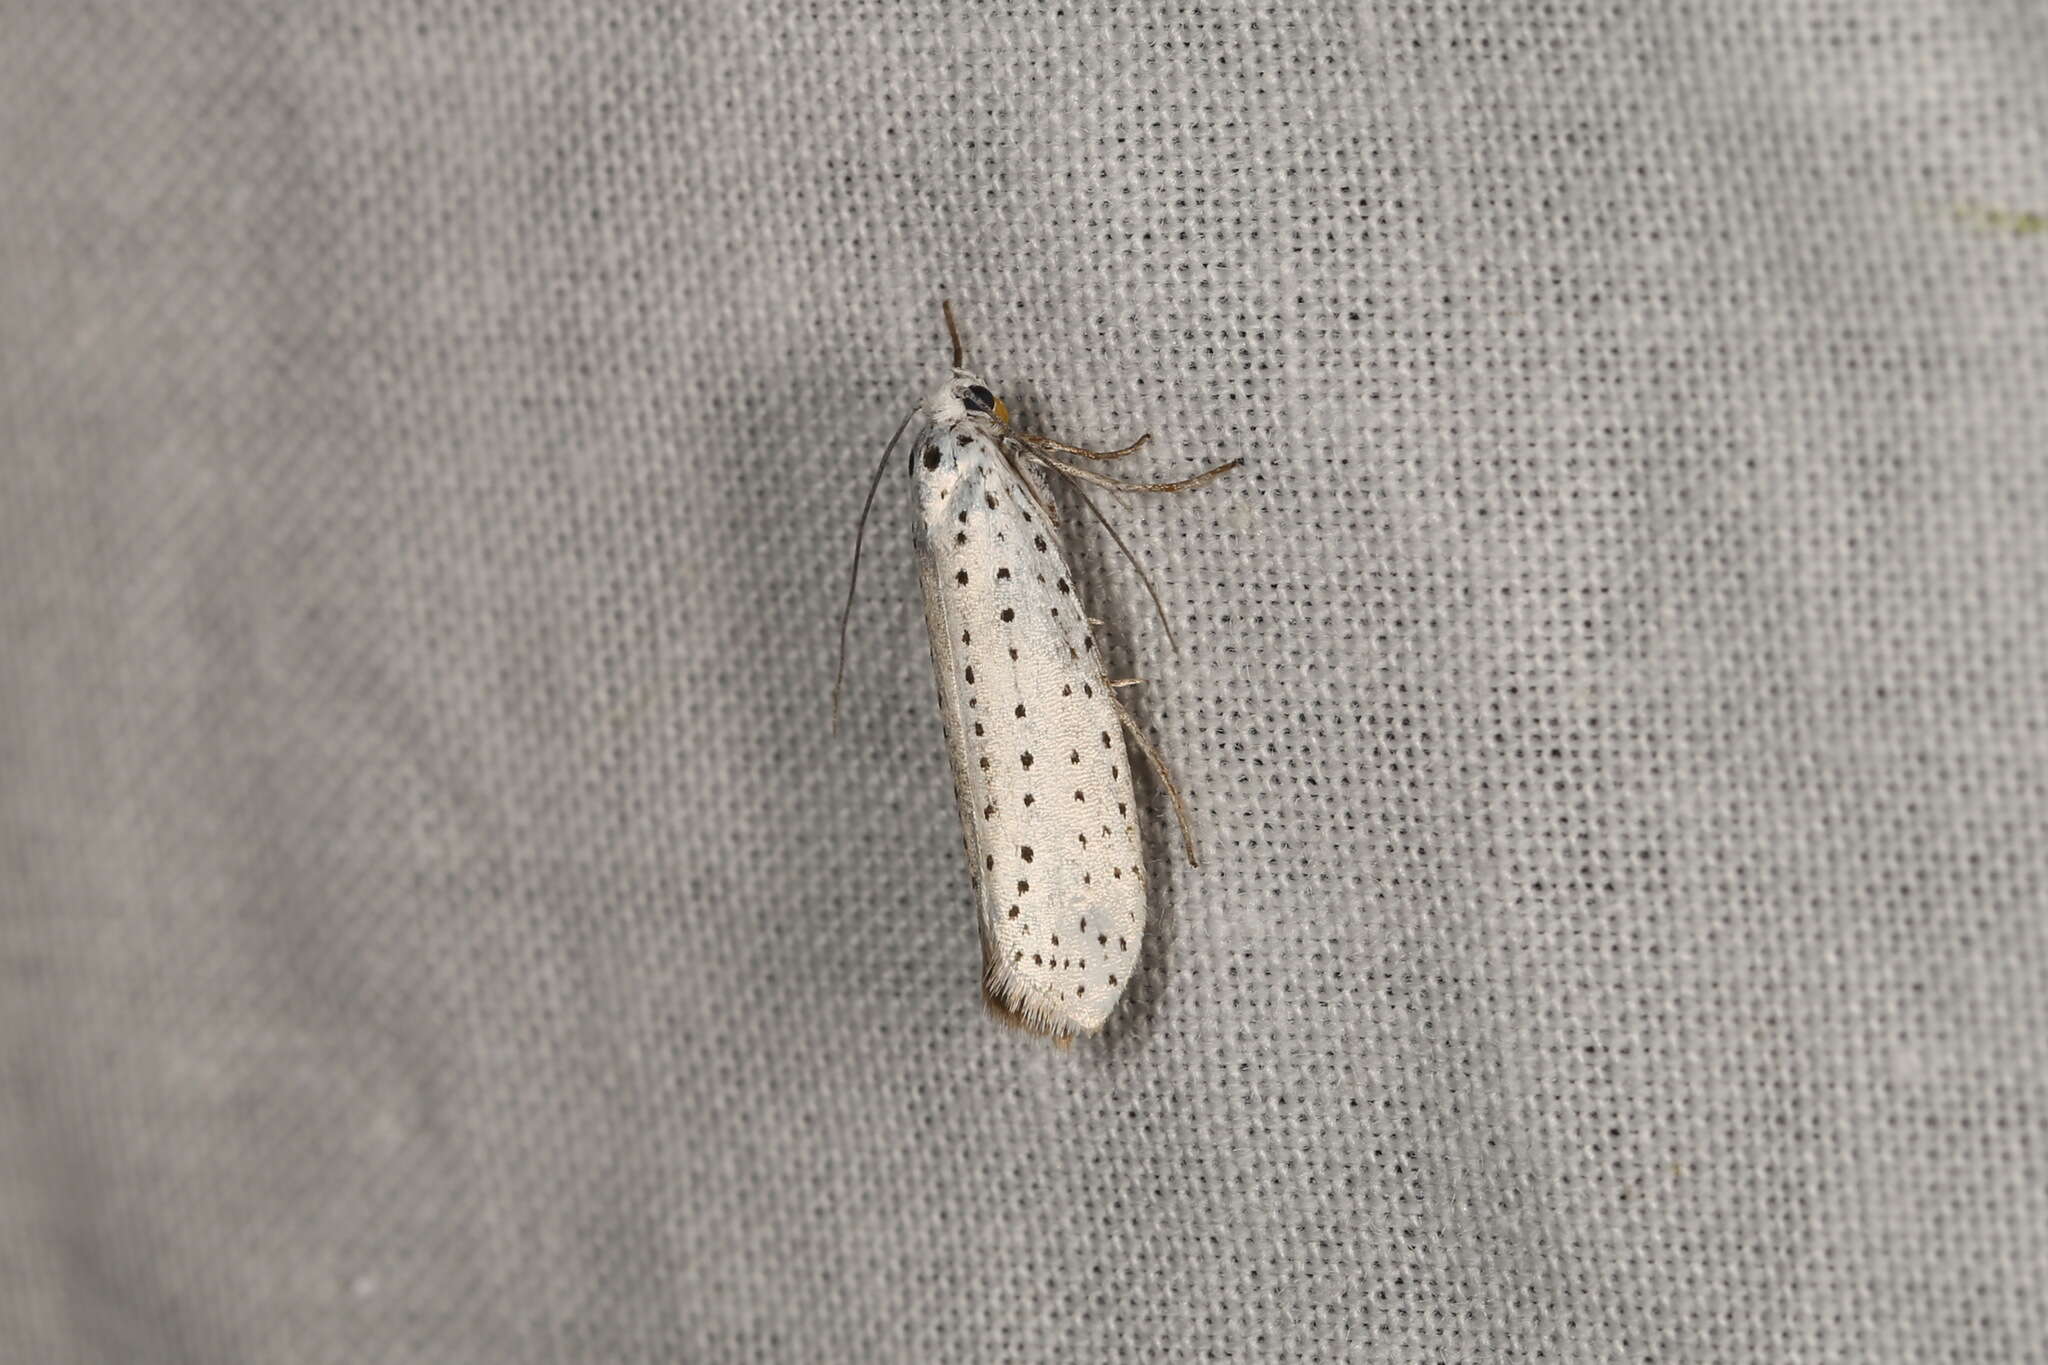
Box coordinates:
[834,303,1239,1040]
